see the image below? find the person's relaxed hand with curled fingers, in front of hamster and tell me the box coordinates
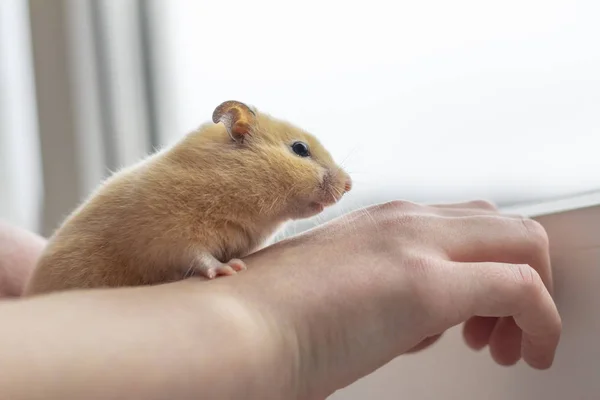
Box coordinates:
[231,202,561,398]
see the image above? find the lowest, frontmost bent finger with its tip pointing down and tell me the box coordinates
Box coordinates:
[431,263,562,369]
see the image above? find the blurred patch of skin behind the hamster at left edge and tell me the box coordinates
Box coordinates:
[0,221,46,299]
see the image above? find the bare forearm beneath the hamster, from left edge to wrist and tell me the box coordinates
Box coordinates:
[0,281,293,399]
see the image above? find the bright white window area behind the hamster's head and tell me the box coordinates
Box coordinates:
[158,0,600,209]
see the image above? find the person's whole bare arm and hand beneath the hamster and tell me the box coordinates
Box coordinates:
[0,203,561,400]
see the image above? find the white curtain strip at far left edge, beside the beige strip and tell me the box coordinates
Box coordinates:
[0,0,42,231]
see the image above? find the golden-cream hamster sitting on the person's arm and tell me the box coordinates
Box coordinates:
[25,101,352,295]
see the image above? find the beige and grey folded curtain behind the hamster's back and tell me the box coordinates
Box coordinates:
[13,0,159,236]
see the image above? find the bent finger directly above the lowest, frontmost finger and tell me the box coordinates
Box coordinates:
[436,215,552,293]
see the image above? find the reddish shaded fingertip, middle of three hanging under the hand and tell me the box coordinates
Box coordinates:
[489,317,522,366]
